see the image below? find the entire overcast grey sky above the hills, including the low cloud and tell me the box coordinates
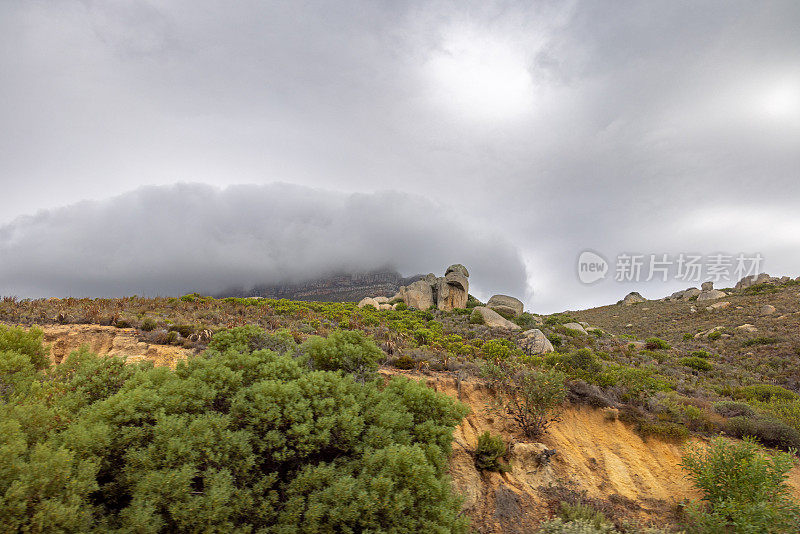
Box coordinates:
[0,0,800,313]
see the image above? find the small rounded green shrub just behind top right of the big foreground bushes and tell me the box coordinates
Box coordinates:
[301,330,384,380]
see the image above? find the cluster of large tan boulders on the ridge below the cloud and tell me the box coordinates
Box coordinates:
[358,263,469,311]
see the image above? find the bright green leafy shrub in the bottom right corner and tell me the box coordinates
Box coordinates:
[681,438,800,534]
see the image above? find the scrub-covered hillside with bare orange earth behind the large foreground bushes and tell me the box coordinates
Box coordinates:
[0,281,800,533]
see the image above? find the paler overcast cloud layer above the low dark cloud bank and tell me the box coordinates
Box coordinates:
[0,0,800,311]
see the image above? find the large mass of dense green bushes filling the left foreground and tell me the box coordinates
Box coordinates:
[0,329,466,534]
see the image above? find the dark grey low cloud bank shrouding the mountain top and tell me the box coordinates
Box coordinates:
[0,184,525,302]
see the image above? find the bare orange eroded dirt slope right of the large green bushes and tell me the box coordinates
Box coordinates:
[386,371,800,533]
